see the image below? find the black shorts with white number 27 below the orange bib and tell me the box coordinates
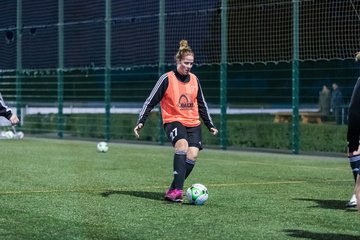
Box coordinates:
[164,122,202,150]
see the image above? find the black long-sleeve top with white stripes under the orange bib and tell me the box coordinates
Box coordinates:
[137,70,215,130]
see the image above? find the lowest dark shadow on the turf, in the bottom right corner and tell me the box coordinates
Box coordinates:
[284,229,360,240]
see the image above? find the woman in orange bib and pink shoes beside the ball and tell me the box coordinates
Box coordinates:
[134,40,218,202]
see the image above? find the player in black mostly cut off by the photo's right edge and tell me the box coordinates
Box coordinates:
[346,52,360,211]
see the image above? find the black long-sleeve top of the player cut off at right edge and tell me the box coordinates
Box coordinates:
[347,78,360,153]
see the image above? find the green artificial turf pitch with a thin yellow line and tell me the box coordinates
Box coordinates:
[0,138,360,240]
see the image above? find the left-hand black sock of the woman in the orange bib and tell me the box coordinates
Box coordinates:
[170,151,186,190]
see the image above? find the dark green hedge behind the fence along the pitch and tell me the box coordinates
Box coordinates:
[23,112,347,152]
